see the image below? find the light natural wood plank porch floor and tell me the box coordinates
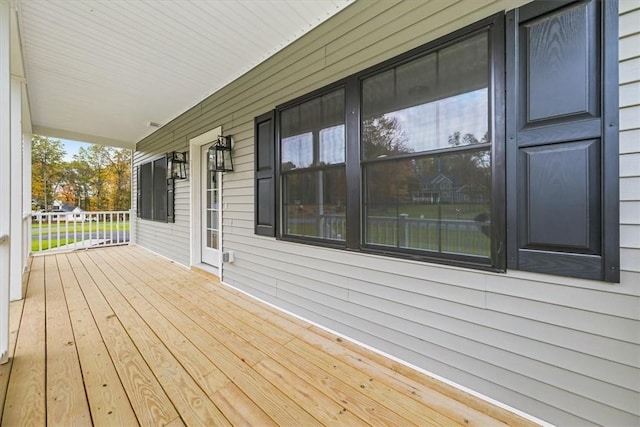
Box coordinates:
[0,246,531,426]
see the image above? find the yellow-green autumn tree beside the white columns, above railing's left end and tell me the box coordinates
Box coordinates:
[31,135,66,210]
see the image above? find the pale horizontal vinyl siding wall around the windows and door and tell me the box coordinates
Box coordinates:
[134,0,640,425]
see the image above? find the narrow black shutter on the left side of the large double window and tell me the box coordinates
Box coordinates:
[254,111,276,237]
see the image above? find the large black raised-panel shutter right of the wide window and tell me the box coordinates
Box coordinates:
[507,0,619,281]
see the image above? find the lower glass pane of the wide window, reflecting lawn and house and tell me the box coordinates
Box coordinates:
[365,150,491,258]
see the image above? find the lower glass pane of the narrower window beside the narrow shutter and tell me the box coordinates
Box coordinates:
[283,167,346,241]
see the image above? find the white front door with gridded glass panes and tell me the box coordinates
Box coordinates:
[200,144,222,268]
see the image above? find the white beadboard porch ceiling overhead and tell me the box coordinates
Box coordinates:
[15,0,352,148]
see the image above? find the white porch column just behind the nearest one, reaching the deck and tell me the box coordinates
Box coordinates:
[9,78,24,301]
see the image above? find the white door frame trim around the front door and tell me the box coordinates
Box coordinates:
[189,126,222,270]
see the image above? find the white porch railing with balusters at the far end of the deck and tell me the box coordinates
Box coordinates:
[31,211,131,255]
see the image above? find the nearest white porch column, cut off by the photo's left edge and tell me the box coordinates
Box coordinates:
[0,0,11,363]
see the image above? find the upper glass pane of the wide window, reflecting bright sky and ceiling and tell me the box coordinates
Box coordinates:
[362,33,489,159]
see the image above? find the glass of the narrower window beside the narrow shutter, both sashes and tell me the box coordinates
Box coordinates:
[280,89,346,241]
